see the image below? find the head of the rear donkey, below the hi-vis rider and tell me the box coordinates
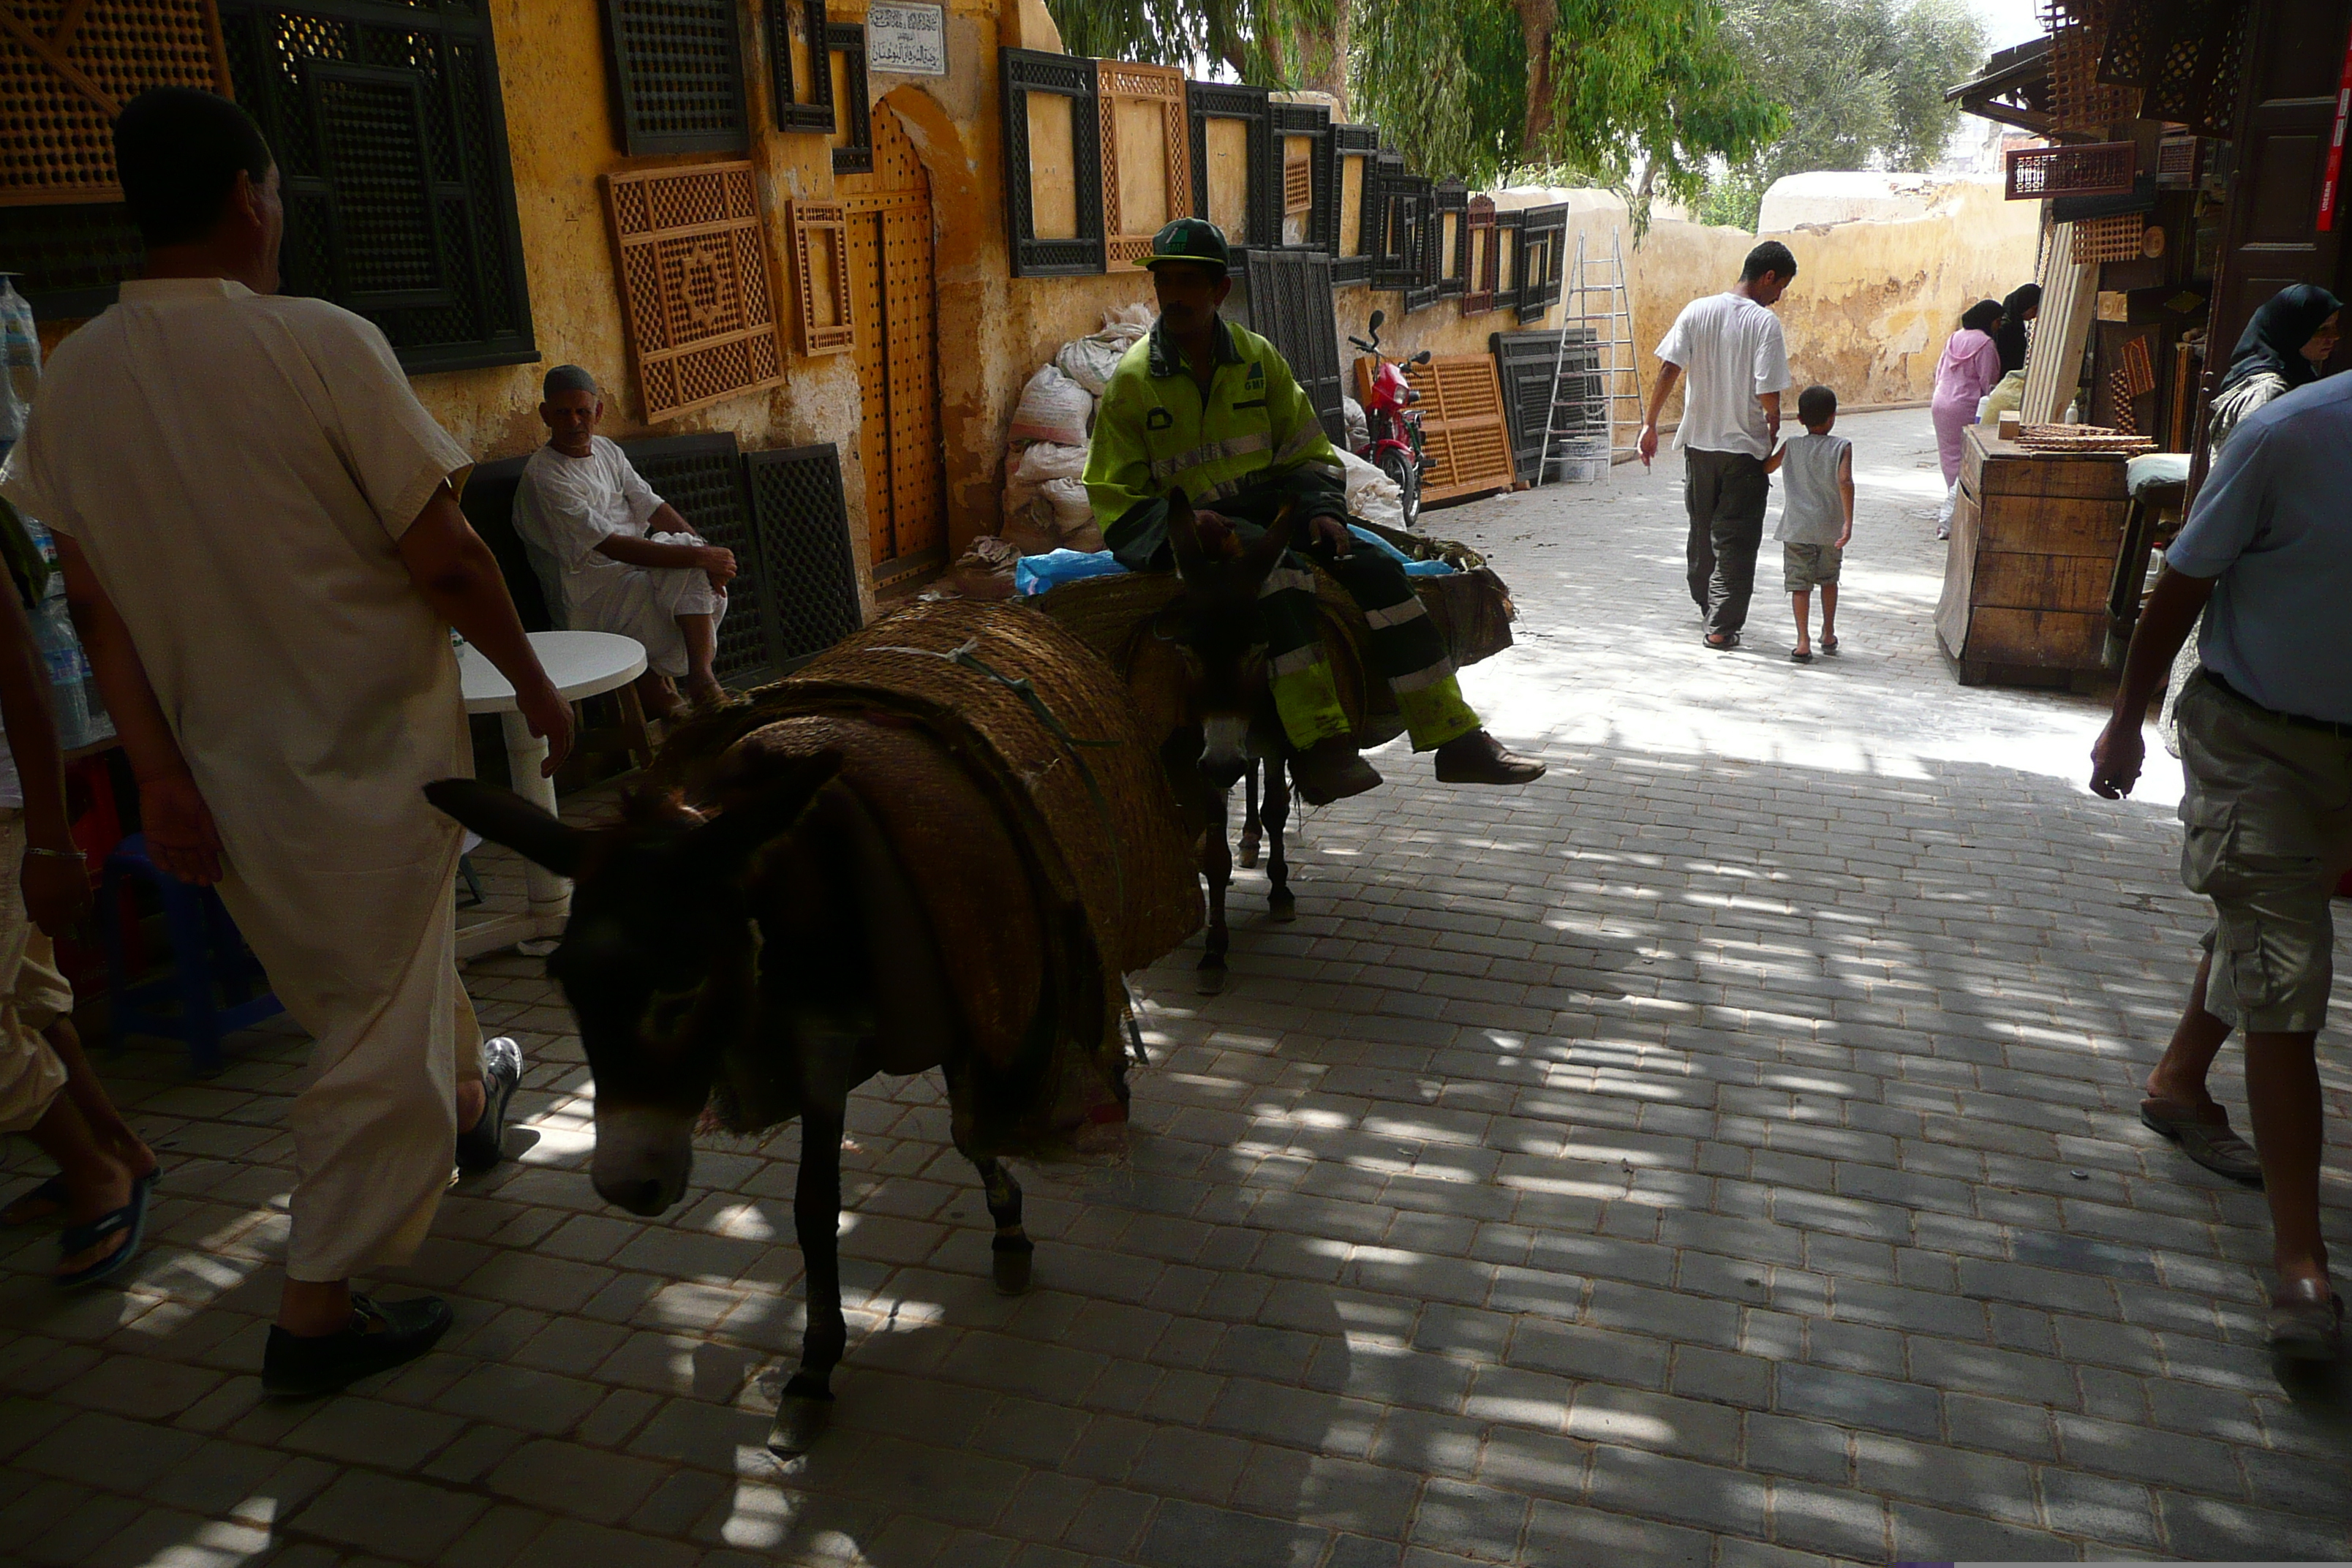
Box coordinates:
[1164,489,1296,790]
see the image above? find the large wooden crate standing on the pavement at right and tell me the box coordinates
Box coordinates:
[1936,428,2128,687]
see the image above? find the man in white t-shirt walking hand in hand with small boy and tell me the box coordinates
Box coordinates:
[1642,240,1797,651]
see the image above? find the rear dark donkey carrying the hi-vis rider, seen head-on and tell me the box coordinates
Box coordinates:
[1126,489,1298,997]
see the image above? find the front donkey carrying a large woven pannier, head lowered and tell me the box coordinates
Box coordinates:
[428,604,1199,1452]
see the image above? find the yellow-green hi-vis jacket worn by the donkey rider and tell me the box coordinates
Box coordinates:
[1087,317,1343,529]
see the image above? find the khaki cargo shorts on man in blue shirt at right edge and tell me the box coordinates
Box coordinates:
[2178,670,2352,1034]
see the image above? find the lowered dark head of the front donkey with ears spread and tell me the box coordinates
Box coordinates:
[426,753,842,1215]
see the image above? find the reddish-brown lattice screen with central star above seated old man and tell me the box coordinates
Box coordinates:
[605,162,783,421]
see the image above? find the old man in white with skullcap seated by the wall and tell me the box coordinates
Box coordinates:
[515,364,736,720]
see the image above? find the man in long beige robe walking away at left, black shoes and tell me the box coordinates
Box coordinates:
[0,89,571,1394]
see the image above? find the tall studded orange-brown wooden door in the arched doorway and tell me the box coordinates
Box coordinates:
[835,106,948,588]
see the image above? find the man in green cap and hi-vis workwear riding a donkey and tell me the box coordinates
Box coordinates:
[1087,219,1543,807]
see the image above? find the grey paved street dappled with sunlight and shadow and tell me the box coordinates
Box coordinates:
[0,412,2352,1568]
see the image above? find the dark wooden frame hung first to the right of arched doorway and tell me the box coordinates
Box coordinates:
[998,50,1103,277]
